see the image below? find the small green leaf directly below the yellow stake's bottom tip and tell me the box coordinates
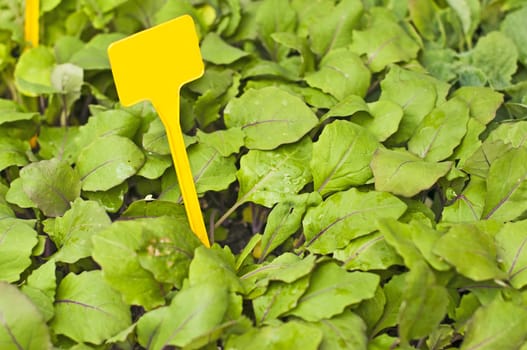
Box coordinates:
[188,245,244,292]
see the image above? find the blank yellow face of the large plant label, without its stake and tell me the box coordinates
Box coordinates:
[108,15,204,106]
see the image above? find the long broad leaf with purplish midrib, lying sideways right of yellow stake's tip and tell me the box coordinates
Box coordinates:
[303,188,406,254]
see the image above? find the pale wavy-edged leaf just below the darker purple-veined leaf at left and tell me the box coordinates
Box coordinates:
[46,198,112,264]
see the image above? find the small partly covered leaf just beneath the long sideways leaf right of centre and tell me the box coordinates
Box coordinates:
[333,232,403,271]
